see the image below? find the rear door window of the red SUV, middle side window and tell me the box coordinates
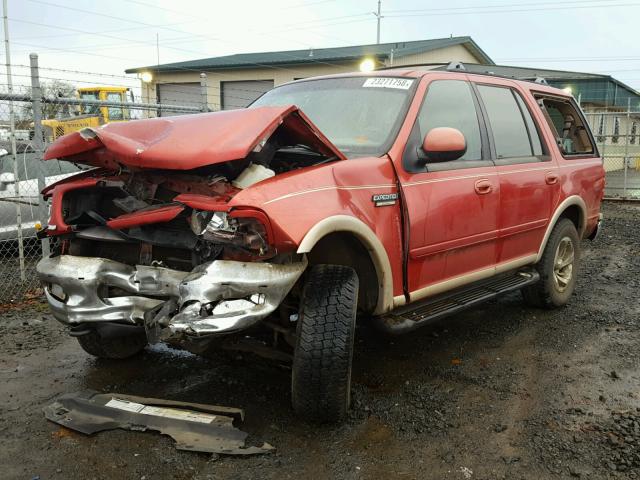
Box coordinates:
[478,85,541,159]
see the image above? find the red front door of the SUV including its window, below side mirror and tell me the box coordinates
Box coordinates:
[398,76,500,301]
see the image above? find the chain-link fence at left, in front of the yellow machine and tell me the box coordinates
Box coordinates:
[0,55,208,304]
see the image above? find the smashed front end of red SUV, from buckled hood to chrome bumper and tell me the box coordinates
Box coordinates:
[38,107,344,341]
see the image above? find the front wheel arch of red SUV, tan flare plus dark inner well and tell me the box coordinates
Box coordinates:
[297,215,393,315]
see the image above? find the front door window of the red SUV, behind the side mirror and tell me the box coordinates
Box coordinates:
[418,80,482,160]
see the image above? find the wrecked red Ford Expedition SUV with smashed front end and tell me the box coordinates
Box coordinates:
[38,70,604,421]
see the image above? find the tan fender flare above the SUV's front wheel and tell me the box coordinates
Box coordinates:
[297,215,393,315]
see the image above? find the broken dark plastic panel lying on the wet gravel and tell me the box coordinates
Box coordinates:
[43,391,275,455]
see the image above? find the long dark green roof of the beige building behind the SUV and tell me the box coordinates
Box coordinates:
[125,37,494,73]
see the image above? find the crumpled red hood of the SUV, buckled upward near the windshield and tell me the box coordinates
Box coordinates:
[44,105,345,170]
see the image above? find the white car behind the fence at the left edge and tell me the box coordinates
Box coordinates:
[0,148,80,241]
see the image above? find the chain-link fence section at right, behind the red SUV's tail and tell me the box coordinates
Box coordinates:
[585,109,640,200]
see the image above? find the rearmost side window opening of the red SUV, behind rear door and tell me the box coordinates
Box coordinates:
[536,95,601,156]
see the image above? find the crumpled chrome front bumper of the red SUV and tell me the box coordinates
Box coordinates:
[37,255,307,338]
